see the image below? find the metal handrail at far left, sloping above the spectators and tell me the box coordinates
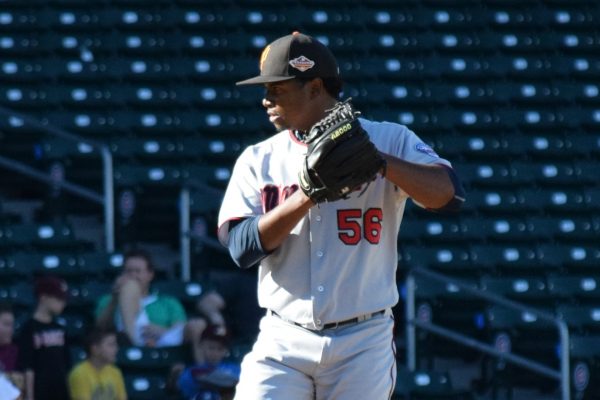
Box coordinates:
[0,106,115,253]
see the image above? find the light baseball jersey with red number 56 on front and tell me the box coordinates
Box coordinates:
[219,119,450,329]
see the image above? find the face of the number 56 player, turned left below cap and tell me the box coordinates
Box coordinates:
[262,80,314,131]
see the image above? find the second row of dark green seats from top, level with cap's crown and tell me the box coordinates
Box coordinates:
[0,30,599,55]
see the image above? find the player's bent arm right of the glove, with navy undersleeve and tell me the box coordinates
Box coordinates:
[381,153,465,211]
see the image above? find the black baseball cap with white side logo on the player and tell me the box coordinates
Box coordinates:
[236,32,340,85]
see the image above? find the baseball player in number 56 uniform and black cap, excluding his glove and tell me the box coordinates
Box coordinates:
[218,32,464,400]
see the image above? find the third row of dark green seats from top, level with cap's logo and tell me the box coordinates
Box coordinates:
[0,53,600,83]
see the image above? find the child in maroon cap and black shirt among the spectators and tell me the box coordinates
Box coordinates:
[17,276,70,400]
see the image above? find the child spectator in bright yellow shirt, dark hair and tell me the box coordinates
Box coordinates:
[69,329,127,400]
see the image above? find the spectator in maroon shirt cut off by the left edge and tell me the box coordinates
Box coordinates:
[0,303,25,398]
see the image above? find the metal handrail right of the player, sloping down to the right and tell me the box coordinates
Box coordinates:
[405,267,571,400]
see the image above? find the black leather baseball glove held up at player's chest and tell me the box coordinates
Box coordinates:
[299,99,385,204]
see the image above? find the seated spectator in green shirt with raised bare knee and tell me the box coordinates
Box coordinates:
[96,250,206,348]
